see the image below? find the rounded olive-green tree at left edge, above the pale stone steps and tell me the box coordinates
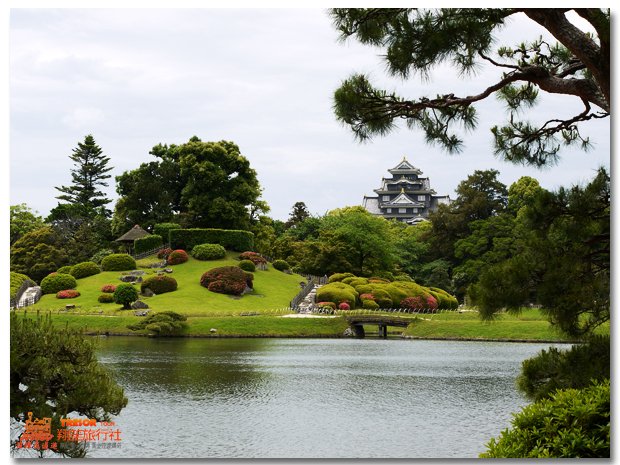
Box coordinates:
[11,226,68,282]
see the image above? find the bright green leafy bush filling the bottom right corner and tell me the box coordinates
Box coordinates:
[480,380,611,458]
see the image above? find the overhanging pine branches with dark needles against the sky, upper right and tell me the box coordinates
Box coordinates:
[330,8,611,166]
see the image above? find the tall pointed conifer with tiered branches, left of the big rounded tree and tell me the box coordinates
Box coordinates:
[56,134,113,217]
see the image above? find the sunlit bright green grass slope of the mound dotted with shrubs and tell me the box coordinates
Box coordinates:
[29,252,304,316]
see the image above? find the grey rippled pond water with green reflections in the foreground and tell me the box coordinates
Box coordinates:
[89,337,560,458]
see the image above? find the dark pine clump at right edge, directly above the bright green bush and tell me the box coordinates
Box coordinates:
[517,336,611,400]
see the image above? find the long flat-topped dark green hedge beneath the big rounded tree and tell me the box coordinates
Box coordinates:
[170,228,254,252]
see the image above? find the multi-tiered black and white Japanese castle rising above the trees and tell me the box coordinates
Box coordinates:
[362,157,450,224]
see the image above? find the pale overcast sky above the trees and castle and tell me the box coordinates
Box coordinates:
[9,8,610,220]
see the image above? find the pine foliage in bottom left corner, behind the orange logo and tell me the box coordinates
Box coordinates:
[10,313,127,457]
